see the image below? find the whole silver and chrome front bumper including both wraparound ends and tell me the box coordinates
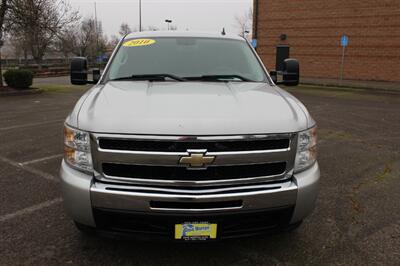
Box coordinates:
[60,162,320,226]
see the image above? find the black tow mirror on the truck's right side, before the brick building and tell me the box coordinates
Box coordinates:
[269,58,300,86]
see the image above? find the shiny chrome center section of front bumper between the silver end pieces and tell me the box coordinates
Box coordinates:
[90,181,298,213]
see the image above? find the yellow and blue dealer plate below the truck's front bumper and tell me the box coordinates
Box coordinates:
[175,222,217,240]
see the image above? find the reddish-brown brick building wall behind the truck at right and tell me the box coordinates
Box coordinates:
[253,0,400,81]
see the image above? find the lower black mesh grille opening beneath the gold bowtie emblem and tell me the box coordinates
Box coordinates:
[103,162,286,181]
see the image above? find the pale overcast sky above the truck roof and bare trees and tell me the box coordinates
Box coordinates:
[70,0,253,36]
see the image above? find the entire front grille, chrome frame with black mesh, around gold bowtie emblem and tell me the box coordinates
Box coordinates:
[91,134,297,187]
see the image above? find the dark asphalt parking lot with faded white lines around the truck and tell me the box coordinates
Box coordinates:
[0,82,400,265]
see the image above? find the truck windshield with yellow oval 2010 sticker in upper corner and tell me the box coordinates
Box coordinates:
[108,37,266,82]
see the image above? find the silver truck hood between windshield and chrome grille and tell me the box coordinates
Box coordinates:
[74,81,310,135]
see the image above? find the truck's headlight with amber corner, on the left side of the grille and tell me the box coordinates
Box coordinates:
[64,125,93,173]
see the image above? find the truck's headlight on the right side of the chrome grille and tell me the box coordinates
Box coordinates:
[294,127,317,172]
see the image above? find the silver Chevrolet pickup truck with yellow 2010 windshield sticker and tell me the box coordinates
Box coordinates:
[60,32,320,241]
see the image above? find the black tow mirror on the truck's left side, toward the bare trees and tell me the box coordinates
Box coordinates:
[71,57,101,85]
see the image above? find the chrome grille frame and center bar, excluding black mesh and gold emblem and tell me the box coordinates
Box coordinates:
[91,133,297,186]
